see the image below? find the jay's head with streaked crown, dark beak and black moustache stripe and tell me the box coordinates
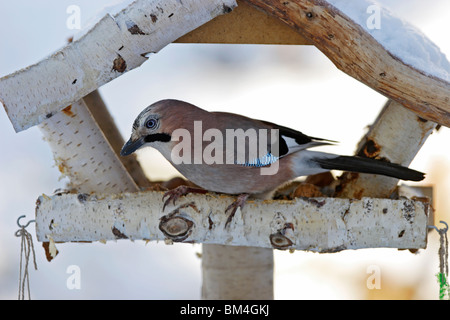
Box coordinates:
[120,100,196,156]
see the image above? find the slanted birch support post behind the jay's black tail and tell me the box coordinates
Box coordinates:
[336,101,436,198]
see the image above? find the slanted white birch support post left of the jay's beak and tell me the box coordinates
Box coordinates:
[40,100,138,193]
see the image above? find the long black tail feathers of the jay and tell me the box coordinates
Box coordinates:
[310,155,425,181]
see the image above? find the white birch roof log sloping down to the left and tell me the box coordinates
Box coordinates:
[0,0,236,131]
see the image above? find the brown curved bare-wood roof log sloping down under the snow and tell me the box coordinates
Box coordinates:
[246,0,450,127]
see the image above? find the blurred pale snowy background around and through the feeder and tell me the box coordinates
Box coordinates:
[0,0,450,299]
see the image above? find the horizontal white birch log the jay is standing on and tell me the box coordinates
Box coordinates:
[36,192,431,252]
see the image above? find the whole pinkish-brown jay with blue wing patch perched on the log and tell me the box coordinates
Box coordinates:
[120,100,424,224]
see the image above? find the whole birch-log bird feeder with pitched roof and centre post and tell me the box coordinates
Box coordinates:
[0,0,450,299]
